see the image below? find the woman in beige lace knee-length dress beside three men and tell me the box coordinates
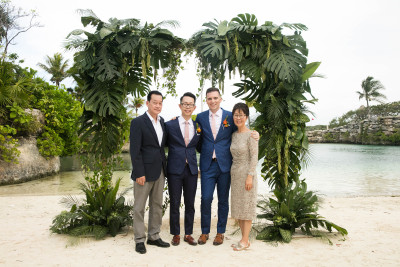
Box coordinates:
[231,103,258,251]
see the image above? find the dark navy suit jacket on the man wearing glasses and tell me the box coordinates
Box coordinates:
[165,119,200,175]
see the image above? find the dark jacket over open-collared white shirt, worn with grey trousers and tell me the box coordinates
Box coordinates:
[129,113,167,182]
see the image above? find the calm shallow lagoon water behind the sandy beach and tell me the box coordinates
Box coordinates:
[0,144,400,197]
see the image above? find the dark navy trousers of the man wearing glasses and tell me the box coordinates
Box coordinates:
[168,165,198,235]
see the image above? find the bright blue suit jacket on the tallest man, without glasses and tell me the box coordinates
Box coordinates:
[196,109,237,172]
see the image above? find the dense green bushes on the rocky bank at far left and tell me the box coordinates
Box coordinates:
[0,55,82,162]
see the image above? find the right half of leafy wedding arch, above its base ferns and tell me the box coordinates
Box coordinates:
[189,14,346,243]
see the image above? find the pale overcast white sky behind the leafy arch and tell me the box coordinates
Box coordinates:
[9,0,400,125]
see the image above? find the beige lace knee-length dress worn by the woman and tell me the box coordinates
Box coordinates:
[231,131,258,220]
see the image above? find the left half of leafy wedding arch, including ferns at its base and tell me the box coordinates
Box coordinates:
[52,10,183,238]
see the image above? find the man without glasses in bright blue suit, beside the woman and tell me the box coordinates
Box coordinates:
[196,88,259,245]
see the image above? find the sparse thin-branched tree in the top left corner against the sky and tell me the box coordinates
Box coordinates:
[0,0,42,59]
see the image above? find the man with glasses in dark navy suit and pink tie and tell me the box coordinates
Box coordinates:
[165,92,201,246]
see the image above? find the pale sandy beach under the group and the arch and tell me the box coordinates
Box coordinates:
[0,196,400,266]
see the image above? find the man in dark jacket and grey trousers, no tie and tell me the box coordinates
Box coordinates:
[129,91,170,254]
